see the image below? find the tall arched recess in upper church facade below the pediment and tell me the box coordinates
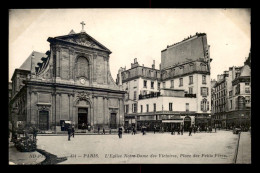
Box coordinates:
[75,56,90,79]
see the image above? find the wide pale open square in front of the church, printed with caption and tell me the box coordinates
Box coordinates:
[37,130,238,164]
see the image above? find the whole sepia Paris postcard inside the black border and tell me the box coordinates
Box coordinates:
[8,8,251,165]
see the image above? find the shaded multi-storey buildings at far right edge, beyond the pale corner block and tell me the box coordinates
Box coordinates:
[212,54,251,128]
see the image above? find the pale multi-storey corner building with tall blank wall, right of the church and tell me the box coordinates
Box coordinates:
[117,33,211,129]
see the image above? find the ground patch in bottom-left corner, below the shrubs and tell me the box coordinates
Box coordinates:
[9,142,45,165]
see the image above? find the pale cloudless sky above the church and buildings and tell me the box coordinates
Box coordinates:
[9,8,251,81]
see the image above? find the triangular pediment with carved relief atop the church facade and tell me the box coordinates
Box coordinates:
[55,32,111,53]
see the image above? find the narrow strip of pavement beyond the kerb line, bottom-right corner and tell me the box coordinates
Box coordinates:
[236,132,251,164]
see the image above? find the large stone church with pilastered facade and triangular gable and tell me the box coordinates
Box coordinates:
[10,25,125,132]
